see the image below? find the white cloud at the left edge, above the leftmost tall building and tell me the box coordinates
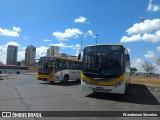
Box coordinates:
[0,27,21,37]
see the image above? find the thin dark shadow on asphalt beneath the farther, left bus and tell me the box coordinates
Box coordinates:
[39,80,81,86]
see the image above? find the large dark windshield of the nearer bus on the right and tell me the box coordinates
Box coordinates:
[83,45,123,78]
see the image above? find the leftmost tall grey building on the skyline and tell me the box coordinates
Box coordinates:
[6,45,18,65]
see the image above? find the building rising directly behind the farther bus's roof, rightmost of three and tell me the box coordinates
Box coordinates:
[47,46,60,56]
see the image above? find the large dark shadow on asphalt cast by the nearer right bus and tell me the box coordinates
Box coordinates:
[86,84,160,105]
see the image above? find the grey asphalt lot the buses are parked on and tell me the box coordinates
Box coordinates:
[0,74,160,120]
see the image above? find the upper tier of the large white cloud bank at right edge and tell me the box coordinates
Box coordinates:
[126,19,160,35]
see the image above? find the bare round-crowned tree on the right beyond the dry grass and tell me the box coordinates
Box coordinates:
[142,61,155,77]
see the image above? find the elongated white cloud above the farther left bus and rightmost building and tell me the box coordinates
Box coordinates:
[53,28,82,41]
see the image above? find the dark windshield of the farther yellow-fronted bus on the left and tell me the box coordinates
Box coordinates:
[38,59,54,74]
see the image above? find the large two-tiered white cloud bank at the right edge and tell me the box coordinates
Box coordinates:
[120,19,160,42]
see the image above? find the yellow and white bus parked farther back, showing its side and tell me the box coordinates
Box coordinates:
[37,56,82,84]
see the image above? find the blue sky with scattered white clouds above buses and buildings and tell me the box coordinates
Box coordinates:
[0,0,160,71]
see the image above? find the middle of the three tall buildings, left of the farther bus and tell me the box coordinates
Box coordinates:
[25,45,36,65]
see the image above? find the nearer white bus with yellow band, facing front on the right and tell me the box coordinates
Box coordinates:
[81,44,130,94]
